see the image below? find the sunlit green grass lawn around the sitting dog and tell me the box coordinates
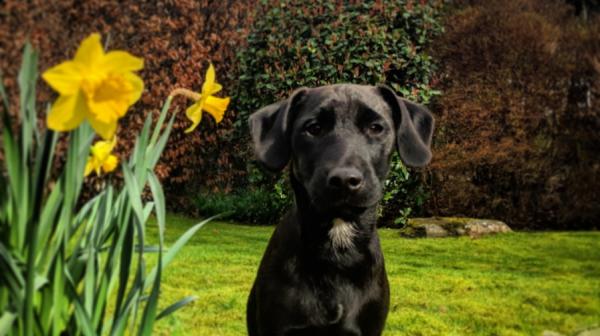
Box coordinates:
[150,215,600,336]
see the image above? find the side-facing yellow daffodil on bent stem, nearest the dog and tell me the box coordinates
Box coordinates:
[171,63,230,133]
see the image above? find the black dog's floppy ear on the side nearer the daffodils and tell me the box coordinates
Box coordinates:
[248,88,307,171]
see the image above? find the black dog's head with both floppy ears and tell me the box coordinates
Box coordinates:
[249,84,434,218]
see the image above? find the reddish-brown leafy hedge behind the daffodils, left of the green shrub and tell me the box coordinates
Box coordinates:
[0,0,254,210]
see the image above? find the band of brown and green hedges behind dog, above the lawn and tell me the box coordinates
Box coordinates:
[0,0,600,229]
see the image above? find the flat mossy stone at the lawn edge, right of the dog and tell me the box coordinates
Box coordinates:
[400,217,512,238]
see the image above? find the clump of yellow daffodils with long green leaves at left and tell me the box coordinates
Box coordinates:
[0,34,218,336]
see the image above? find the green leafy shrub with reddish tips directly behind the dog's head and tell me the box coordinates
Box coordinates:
[234,0,442,223]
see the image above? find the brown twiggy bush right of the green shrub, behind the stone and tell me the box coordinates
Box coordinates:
[427,0,600,228]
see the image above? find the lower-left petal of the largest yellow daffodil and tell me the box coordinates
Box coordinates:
[46,92,87,132]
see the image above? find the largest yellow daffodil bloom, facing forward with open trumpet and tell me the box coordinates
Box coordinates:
[42,33,144,140]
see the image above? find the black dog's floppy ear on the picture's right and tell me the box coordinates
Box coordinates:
[378,86,434,167]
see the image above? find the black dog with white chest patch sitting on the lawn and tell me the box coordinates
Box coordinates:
[247,84,433,336]
